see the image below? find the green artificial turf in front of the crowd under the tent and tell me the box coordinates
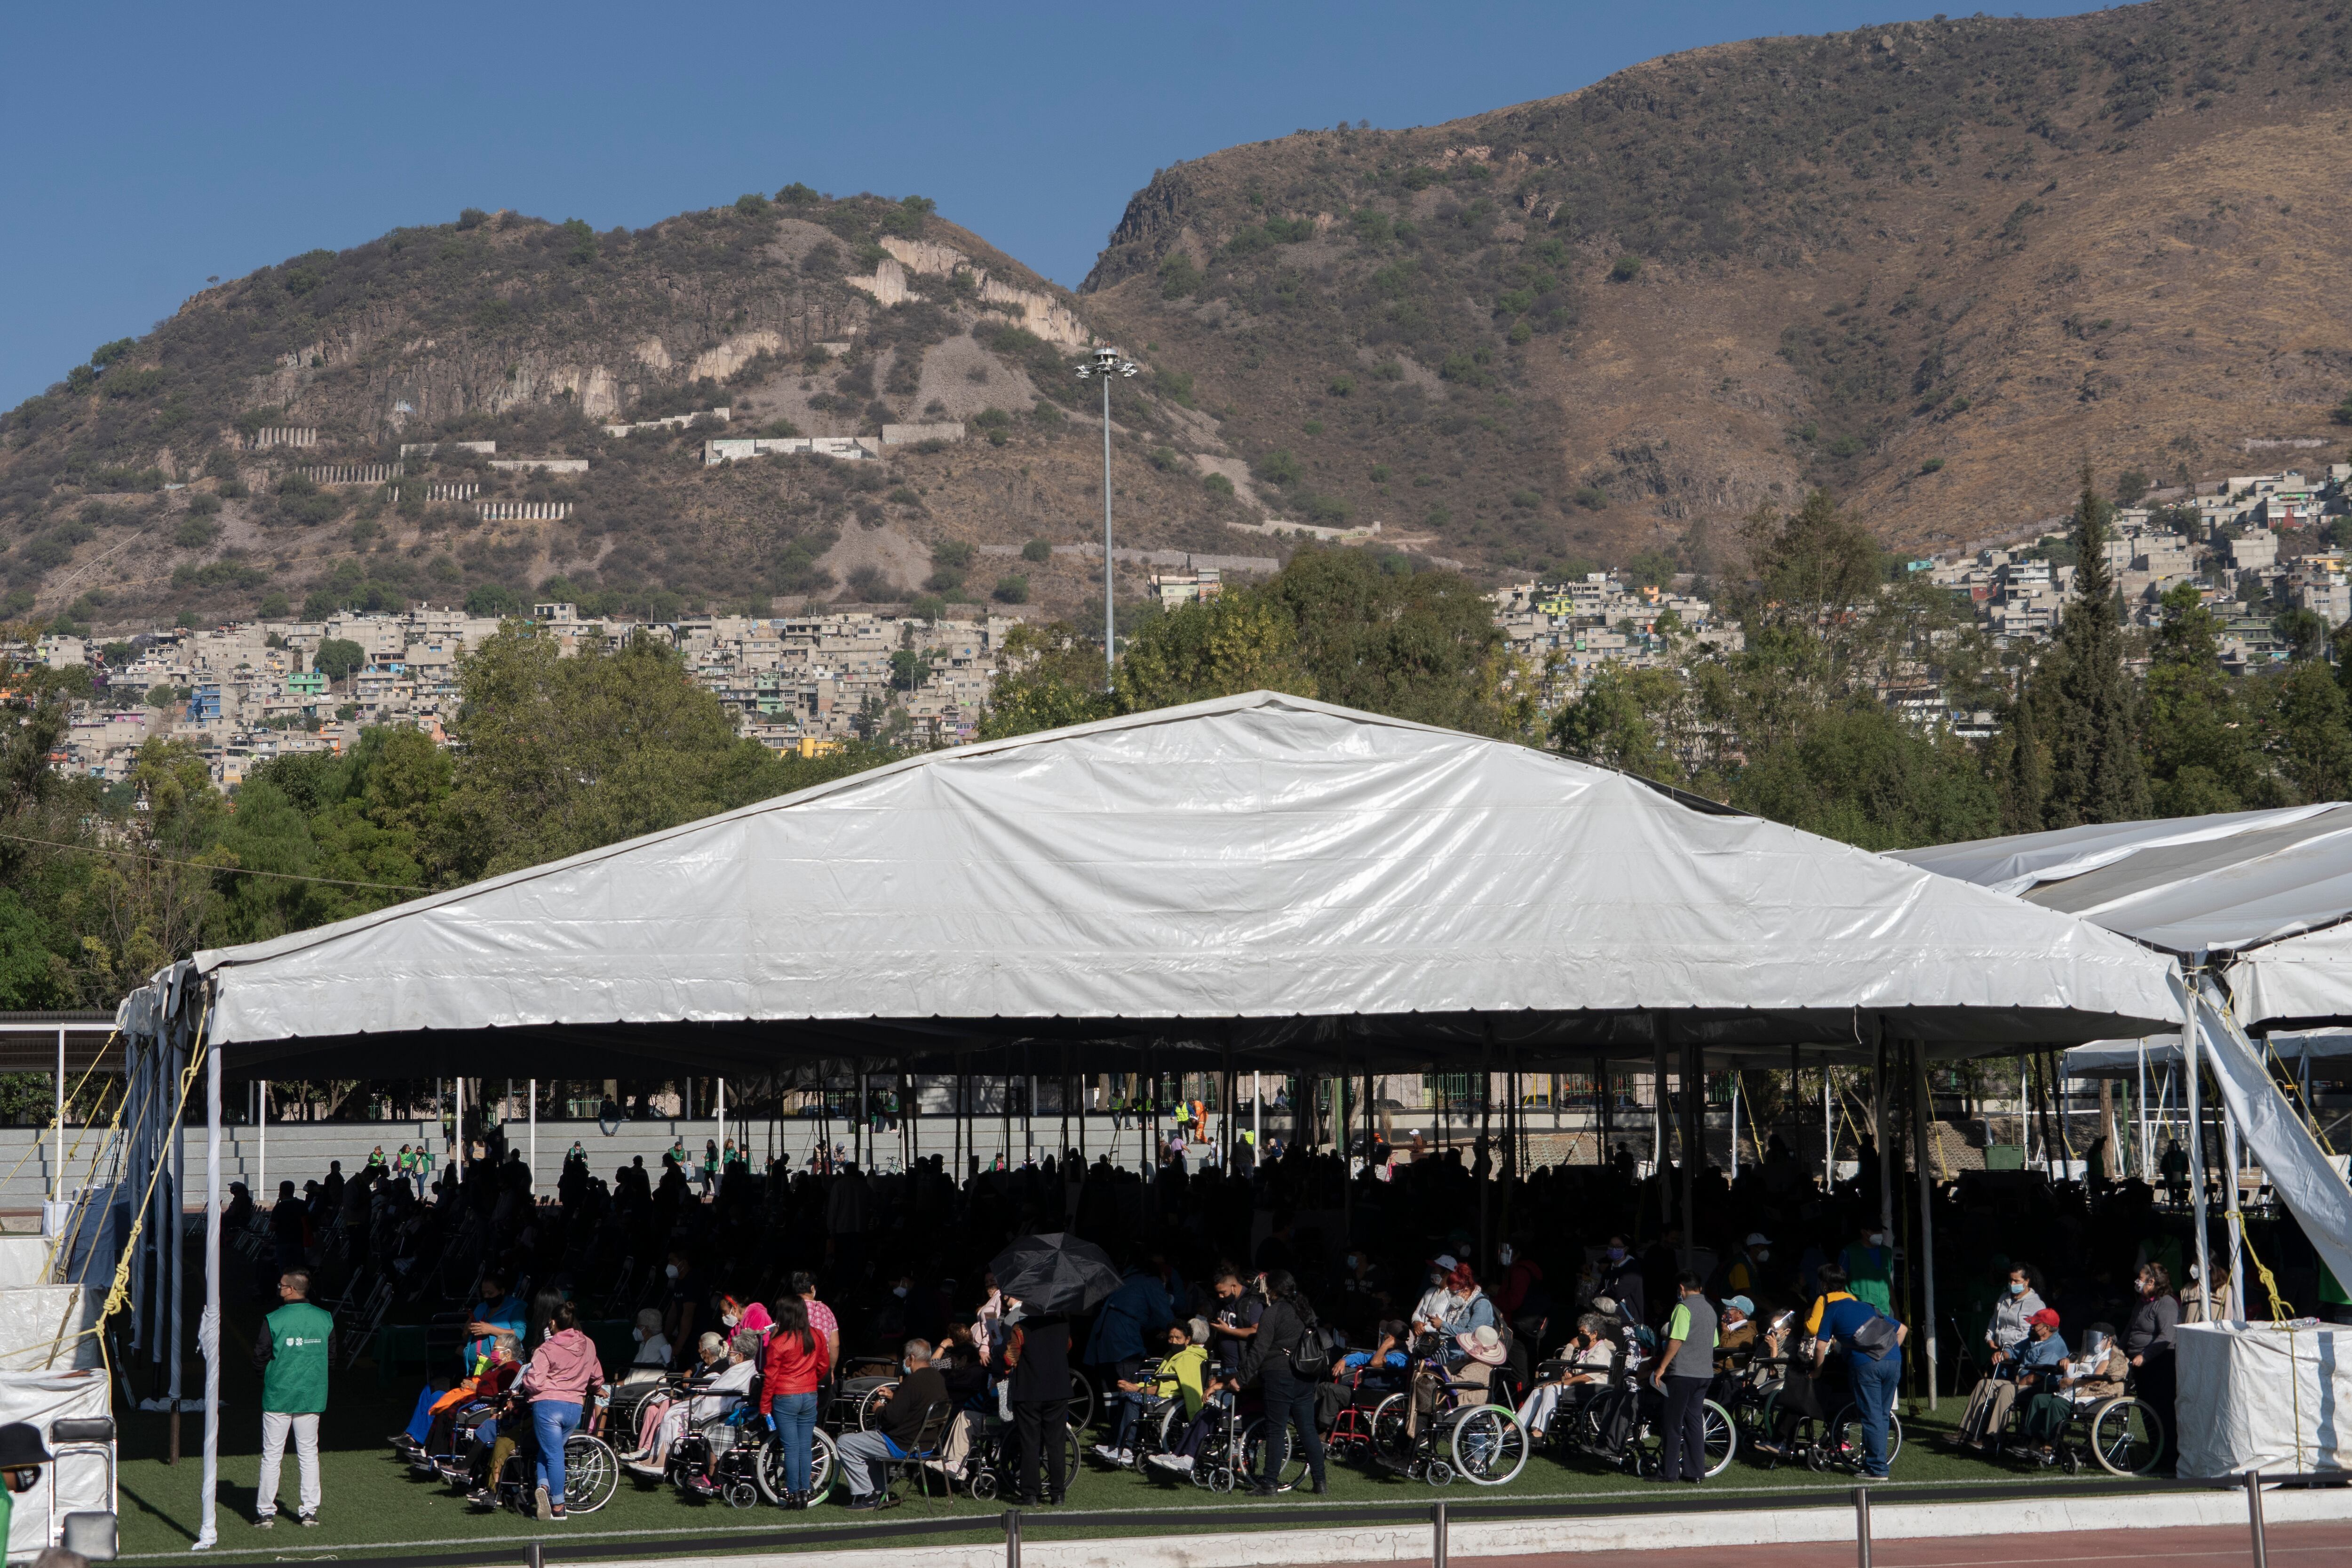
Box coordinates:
[122,1356,2136,1561]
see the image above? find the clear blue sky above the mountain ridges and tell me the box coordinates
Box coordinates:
[0,0,2086,406]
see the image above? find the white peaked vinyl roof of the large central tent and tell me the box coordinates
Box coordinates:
[124,693,2180,1072]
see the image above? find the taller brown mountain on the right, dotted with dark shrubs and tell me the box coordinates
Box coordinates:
[1084,0,2352,566]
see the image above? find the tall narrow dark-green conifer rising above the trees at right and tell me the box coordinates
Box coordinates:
[2034,463,2150,828]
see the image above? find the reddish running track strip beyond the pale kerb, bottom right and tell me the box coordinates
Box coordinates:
[1402,1521,2324,1568]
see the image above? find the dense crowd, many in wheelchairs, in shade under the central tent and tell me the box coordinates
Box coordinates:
[212,1090,2340,1516]
